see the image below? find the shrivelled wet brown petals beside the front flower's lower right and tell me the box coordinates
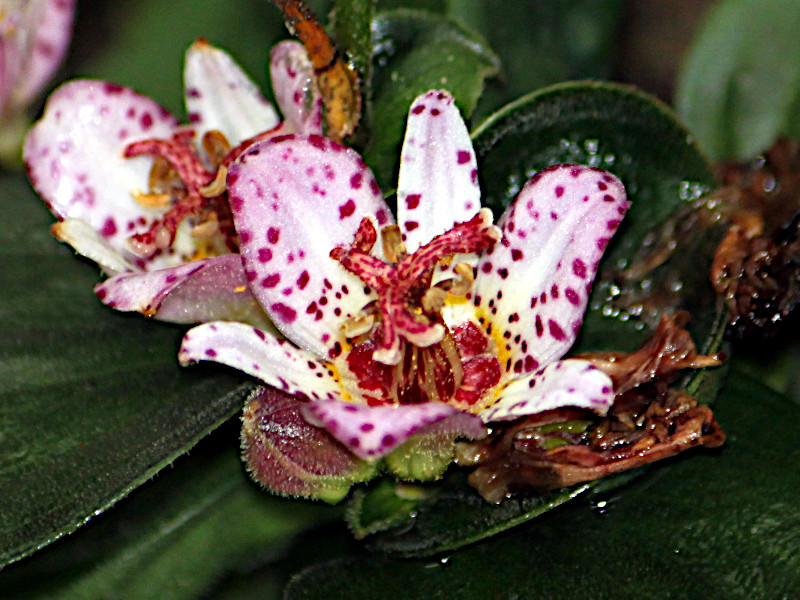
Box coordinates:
[456,313,725,502]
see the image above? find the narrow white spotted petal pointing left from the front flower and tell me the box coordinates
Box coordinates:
[178,321,341,400]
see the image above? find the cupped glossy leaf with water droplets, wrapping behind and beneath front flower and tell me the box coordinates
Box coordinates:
[349,83,725,555]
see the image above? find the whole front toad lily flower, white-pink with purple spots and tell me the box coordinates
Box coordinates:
[180,91,628,488]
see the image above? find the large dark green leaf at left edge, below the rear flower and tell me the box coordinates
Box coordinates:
[0,177,250,564]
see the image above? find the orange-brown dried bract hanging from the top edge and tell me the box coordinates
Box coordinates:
[273,0,361,142]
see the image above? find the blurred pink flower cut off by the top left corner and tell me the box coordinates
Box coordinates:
[0,0,75,160]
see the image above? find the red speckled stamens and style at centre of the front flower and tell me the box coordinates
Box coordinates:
[331,209,501,405]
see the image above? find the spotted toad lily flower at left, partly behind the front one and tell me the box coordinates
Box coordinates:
[24,40,322,325]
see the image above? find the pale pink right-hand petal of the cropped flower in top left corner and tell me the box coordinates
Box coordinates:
[5,0,75,108]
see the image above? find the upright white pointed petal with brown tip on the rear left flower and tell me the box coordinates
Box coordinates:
[183,40,280,146]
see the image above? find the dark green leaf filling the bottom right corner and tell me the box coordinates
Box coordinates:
[285,374,800,600]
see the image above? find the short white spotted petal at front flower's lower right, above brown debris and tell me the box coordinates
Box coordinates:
[480,359,614,423]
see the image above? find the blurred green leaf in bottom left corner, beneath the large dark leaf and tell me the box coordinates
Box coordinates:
[0,424,340,600]
